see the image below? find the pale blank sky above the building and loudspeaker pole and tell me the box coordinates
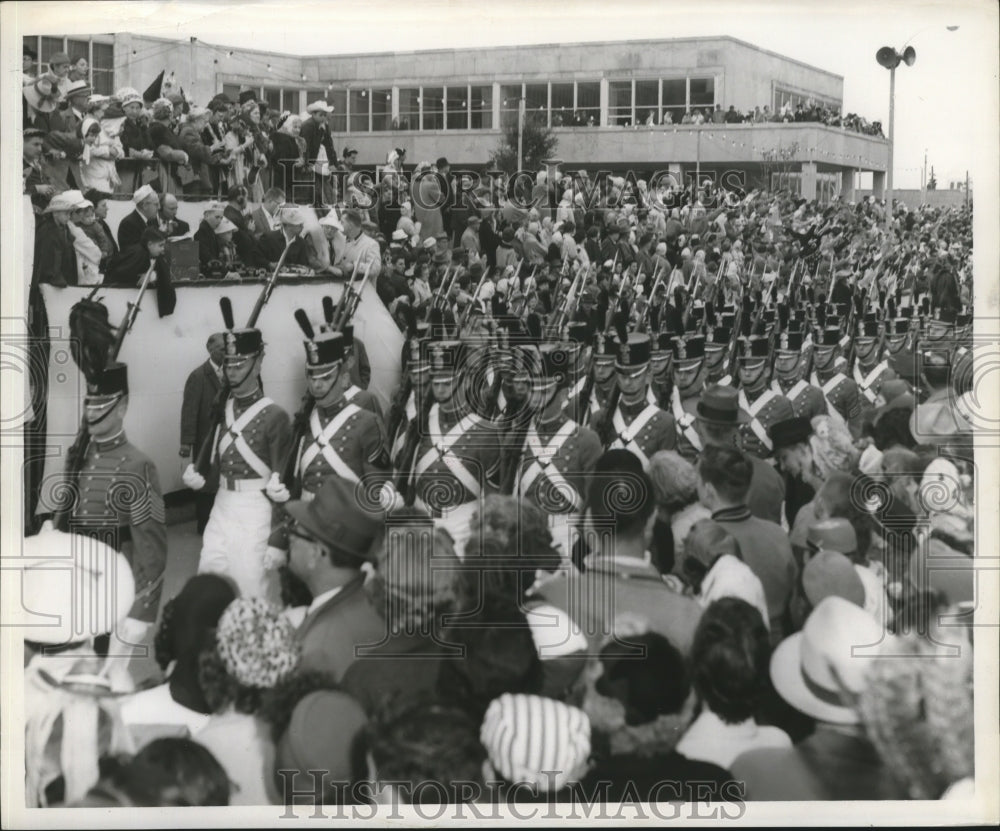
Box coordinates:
[9,0,1000,188]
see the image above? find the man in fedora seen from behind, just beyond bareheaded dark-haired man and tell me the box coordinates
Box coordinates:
[695,384,785,525]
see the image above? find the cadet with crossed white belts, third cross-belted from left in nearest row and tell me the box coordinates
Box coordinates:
[410,340,500,551]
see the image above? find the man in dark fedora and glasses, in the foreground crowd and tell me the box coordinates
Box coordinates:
[285,475,385,682]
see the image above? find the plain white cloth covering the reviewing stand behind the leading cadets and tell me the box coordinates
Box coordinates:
[39,277,403,500]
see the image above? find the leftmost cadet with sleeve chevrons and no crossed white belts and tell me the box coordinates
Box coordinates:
[69,363,167,644]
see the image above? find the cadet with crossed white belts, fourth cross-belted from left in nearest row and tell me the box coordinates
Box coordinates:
[514,341,602,554]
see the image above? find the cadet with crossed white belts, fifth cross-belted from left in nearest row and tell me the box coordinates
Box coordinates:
[604,332,677,469]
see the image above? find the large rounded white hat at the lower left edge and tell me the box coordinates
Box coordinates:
[15,522,135,644]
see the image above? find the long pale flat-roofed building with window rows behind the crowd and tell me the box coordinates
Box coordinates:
[26,34,889,200]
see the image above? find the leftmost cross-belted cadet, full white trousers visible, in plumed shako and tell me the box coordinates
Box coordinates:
[183,297,292,600]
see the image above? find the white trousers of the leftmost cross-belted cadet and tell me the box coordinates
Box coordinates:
[198,490,279,602]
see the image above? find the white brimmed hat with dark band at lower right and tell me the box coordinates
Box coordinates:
[771,596,891,724]
